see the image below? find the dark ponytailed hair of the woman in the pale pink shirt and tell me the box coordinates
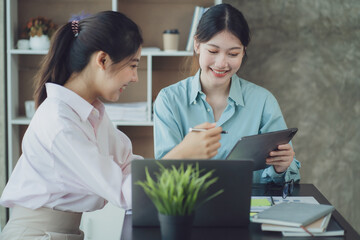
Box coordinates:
[34,11,143,107]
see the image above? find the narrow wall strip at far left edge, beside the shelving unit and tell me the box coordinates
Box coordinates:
[0,1,6,230]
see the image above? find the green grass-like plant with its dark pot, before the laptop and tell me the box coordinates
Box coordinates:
[136,163,224,240]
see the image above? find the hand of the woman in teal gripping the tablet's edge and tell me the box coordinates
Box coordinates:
[266,143,295,173]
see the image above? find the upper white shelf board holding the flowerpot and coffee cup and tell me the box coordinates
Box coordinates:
[10,49,193,57]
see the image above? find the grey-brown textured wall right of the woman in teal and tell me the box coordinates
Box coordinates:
[228,0,360,232]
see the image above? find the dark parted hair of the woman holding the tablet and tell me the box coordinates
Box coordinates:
[188,3,250,73]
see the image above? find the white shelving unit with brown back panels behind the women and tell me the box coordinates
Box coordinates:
[5,0,221,176]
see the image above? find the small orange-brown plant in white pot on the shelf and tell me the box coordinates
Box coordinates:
[24,17,56,50]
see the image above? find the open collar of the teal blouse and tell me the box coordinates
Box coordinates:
[189,69,244,106]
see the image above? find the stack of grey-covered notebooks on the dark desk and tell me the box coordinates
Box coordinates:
[251,203,344,237]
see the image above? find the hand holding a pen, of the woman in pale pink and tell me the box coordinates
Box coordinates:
[164,123,222,159]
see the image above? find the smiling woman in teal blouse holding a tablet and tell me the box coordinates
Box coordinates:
[154,4,300,183]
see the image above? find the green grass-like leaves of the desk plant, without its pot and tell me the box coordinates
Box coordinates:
[136,163,224,216]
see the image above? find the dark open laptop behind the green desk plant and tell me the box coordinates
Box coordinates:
[131,159,253,227]
